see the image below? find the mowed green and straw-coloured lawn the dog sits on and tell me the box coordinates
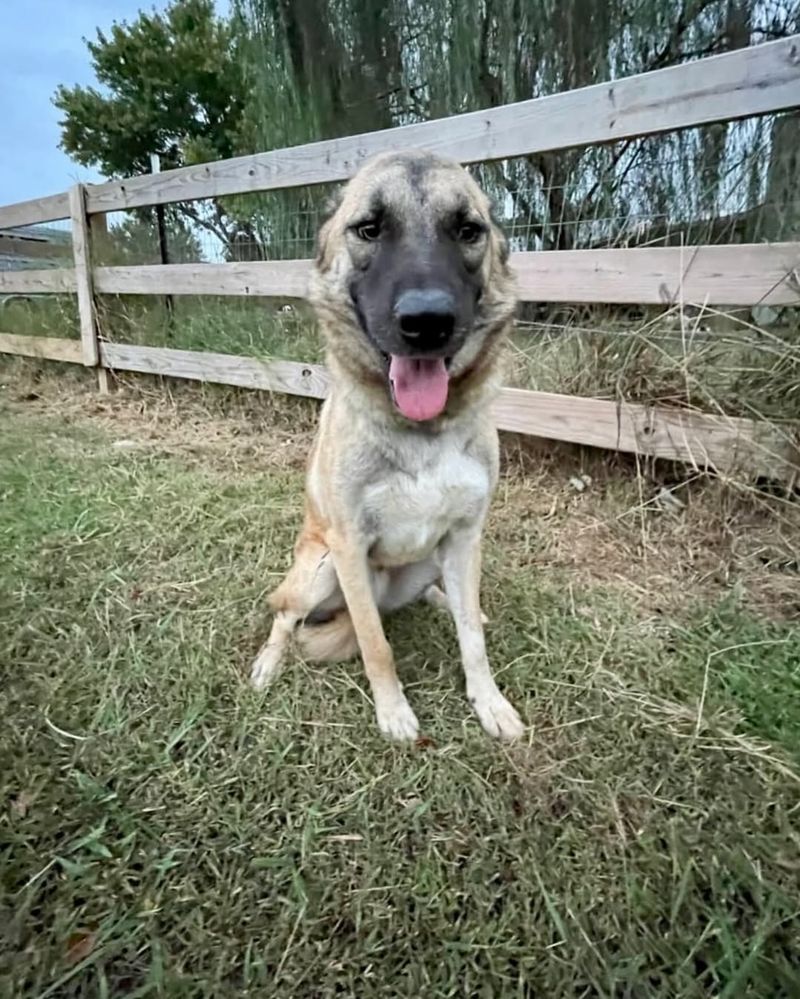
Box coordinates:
[0,368,800,999]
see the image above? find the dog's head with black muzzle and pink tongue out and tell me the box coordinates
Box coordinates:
[311,152,515,421]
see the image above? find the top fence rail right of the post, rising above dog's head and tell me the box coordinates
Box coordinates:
[83,35,800,213]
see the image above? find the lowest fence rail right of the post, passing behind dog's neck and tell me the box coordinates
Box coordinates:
[101,343,800,478]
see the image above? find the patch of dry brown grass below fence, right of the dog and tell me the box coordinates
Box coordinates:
[490,455,800,618]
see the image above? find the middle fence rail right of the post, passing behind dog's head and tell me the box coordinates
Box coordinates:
[90,243,800,305]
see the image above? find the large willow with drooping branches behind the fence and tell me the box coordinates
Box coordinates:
[235,0,800,254]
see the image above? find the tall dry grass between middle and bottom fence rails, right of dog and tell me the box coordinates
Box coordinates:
[509,306,800,425]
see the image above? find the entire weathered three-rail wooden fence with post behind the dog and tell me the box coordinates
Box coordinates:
[0,35,800,478]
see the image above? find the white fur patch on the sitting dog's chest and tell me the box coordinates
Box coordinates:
[363,446,491,565]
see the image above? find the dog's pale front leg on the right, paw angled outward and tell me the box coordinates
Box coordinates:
[442,531,525,740]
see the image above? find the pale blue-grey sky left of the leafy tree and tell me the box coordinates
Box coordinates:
[0,0,227,204]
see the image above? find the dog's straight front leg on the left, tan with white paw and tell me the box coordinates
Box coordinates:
[328,532,419,740]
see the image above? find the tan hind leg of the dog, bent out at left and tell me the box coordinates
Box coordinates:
[250,538,338,690]
